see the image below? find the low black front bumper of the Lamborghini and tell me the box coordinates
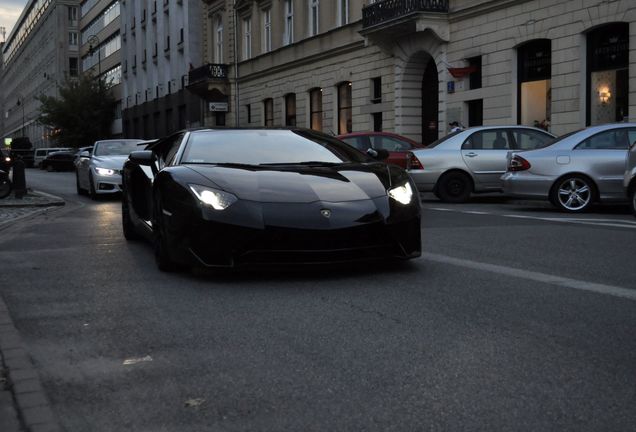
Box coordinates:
[164,197,421,267]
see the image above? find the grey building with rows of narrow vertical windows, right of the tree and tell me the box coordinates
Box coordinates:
[121,0,202,139]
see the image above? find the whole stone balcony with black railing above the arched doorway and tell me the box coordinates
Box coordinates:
[360,0,449,42]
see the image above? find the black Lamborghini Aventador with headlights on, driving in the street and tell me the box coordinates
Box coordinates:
[122,129,421,270]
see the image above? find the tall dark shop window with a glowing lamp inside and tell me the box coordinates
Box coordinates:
[586,23,629,126]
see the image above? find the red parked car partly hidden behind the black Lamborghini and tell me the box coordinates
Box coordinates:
[336,132,424,168]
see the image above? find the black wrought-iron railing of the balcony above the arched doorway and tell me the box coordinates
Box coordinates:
[362,0,448,28]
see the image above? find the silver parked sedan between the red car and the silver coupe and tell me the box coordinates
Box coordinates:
[408,126,555,203]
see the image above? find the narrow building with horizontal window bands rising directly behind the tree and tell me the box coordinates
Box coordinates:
[79,0,123,137]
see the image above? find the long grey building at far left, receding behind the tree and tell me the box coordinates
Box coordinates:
[0,0,79,147]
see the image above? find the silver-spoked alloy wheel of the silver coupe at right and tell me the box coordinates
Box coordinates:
[550,174,596,213]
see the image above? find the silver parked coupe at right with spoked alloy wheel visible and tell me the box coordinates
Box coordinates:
[502,123,636,213]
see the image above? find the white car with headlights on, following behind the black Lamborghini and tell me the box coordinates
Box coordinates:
[75,139,144,199]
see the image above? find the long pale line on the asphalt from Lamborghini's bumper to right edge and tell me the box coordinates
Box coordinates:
[422,252,636,301]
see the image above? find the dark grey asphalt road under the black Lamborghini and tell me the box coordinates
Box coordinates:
[0,170,636,432]
